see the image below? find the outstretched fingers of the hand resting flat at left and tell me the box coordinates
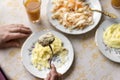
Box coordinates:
[3,24,31,42]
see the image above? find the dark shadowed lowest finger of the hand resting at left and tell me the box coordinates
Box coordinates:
[0,40,20,49]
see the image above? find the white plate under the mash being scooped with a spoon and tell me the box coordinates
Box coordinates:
[21,30,74,78]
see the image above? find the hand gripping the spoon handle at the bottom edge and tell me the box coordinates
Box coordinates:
[44,64,61,80]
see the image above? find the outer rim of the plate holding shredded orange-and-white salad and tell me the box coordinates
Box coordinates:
[46,0,102,35]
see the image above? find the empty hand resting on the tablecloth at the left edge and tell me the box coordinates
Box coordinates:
[0,24,31,48]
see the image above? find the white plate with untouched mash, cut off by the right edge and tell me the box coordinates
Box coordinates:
[95,19,120,63]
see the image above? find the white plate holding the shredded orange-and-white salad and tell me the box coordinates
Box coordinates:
[47,0,102,35]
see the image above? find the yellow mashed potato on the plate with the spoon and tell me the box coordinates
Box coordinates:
[31,37,67,70]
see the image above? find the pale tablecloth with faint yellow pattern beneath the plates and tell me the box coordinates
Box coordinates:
[0,0,120,80]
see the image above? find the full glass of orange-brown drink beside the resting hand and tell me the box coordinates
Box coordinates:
[23,0,41,23]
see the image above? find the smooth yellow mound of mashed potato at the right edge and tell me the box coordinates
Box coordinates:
[103,24,120,48]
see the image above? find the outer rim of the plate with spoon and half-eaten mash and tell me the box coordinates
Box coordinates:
[21,29,75,78]
